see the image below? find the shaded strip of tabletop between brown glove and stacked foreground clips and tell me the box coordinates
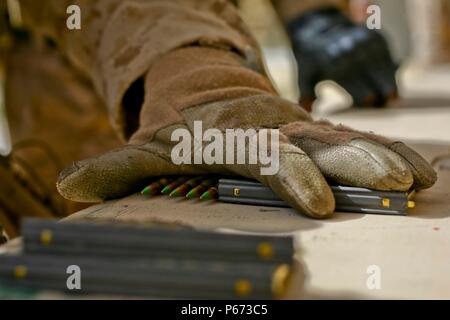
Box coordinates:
[69,195,363,234]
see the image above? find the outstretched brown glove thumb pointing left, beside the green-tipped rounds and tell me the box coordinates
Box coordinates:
[57,144,204,202]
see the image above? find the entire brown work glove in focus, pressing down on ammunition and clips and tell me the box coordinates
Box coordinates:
[57,47,436,218]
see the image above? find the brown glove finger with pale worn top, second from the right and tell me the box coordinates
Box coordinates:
[281,122,413,191]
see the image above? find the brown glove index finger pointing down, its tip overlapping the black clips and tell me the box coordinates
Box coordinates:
[221,131,335,219]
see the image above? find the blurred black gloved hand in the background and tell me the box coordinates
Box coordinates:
[287,8,397,111]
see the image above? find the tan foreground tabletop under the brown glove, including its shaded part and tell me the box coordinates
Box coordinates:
[59,144,450,299]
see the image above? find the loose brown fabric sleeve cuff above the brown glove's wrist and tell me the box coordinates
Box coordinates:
[20,0,260,140]
